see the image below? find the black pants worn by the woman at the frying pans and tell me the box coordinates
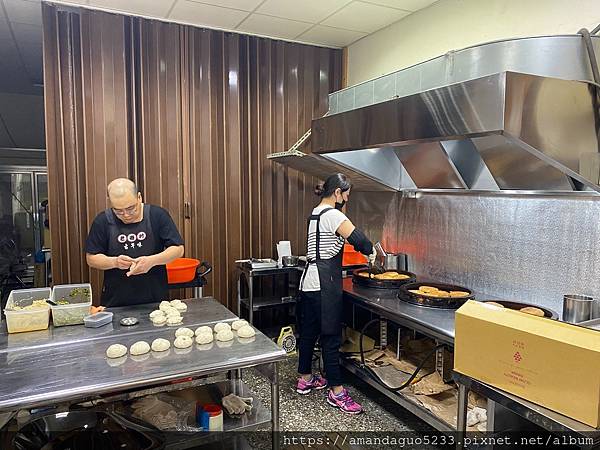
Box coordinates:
[296,291,342,386]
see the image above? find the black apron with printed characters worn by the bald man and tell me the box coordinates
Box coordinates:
[101,204,169,306]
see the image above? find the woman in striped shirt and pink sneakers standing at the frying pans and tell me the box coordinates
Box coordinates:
[296,173,376,414]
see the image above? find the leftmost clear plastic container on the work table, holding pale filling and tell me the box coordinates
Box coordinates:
[4,288,52,333]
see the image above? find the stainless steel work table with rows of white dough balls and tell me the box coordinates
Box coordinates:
[0,298,286,446]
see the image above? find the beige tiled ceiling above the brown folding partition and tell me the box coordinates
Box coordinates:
[54,0,436,47]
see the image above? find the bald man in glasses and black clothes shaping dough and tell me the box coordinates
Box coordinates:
[85,178,183,306]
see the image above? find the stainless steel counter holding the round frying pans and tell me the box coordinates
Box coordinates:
[343,278,455,344]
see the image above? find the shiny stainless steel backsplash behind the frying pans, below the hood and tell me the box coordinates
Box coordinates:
[348,192,600,314]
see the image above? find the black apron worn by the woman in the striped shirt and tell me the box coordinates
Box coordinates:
[300,208,344,334]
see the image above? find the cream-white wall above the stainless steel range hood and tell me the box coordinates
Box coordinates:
[348,0,600,86]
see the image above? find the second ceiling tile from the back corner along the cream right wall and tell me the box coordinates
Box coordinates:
[322,2,410,33]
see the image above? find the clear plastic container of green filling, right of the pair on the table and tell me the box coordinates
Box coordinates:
[52,283,92,327]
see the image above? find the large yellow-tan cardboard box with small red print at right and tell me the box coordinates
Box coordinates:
[454,301,600,428]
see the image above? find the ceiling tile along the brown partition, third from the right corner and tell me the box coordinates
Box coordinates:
[169,0,248,29]
